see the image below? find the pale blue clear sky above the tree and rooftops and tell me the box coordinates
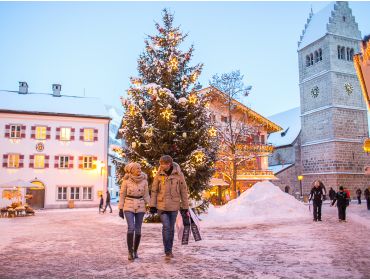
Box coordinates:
[0,2,370,116]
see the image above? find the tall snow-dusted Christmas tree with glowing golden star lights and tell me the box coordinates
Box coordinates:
[118,9,218,206]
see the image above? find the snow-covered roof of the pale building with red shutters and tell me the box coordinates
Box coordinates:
[0,90,109,118]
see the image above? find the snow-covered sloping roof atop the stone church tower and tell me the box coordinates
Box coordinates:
[298,2,335,50]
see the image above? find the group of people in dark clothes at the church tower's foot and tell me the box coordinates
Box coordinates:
[308,180,370,222]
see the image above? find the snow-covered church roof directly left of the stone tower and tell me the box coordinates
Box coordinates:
[267,107,301,147]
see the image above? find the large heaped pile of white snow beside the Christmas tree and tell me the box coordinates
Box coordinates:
[201,181,309,226]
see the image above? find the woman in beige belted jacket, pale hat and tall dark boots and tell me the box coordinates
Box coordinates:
[118,162,150,261]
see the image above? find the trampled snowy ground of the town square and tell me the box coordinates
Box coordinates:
[0,204,370,278]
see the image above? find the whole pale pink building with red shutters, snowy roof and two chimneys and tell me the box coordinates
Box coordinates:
[0,82,110,208]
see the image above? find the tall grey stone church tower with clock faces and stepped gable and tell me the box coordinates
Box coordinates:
[298,2,370,195]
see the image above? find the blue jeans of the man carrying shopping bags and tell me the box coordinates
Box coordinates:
[158,211,178,253]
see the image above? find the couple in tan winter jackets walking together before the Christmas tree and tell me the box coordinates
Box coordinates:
[118,155,189,260]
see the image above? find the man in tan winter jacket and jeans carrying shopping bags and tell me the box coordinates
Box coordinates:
[150,155,190,260]
